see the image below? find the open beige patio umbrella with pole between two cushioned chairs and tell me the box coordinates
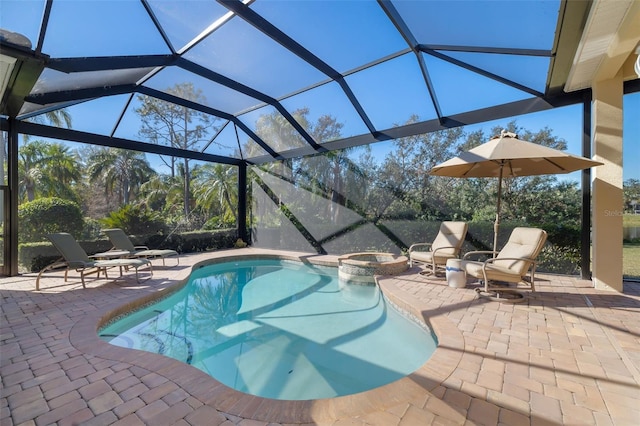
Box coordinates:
[429,130,603,255]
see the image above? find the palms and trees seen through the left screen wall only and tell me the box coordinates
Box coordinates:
[18,140,237,240]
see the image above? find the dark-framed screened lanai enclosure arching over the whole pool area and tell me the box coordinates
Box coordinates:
[0,0,640,282]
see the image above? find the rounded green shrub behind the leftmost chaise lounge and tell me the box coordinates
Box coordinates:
[18,197,84,242]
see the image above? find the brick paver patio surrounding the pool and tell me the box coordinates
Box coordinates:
[0,249,640,426]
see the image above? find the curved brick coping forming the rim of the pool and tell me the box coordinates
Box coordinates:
[69,249,464,423]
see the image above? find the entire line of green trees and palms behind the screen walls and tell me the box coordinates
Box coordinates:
[11,83,640,250]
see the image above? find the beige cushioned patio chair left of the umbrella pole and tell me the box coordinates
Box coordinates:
[409,222,468,275]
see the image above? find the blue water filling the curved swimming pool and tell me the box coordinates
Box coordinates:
[100,260,436,400]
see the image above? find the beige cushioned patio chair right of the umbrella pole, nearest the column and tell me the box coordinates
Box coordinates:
[462,227,547,292]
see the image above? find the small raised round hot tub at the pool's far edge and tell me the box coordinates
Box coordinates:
[338,252,409,284]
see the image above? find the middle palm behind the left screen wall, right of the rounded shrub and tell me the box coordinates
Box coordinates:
[88,148,155,205]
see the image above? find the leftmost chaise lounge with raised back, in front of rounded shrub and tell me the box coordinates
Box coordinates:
[36,232,153,290]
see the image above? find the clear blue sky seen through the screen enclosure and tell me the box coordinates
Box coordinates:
[0,0,640,179]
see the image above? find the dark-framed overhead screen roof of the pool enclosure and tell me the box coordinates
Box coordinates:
[0,0,562,163]
